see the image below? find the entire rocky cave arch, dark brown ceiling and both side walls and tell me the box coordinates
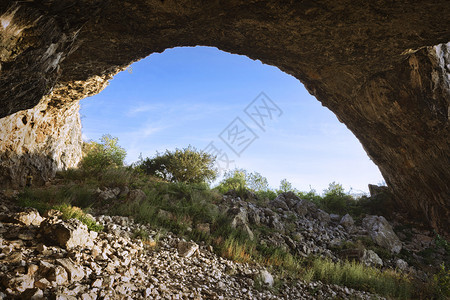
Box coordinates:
[0,0,450,231]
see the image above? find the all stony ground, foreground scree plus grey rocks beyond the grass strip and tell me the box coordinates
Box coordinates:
[0,189,446,299]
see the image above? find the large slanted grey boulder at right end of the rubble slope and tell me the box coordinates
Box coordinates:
[362,216,402,253]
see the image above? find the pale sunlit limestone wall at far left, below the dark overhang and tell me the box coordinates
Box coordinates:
[0,98,82,187]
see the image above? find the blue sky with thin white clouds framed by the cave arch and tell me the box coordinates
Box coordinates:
[81,47,383,192]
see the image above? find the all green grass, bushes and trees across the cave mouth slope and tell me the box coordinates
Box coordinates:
[15,136,444,299]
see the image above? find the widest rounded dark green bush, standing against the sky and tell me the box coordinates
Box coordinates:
[136,146,217,183]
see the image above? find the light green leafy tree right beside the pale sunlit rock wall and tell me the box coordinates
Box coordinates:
[80,134,127,172]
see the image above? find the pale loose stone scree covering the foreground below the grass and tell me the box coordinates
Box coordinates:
[0,198,384,300]
